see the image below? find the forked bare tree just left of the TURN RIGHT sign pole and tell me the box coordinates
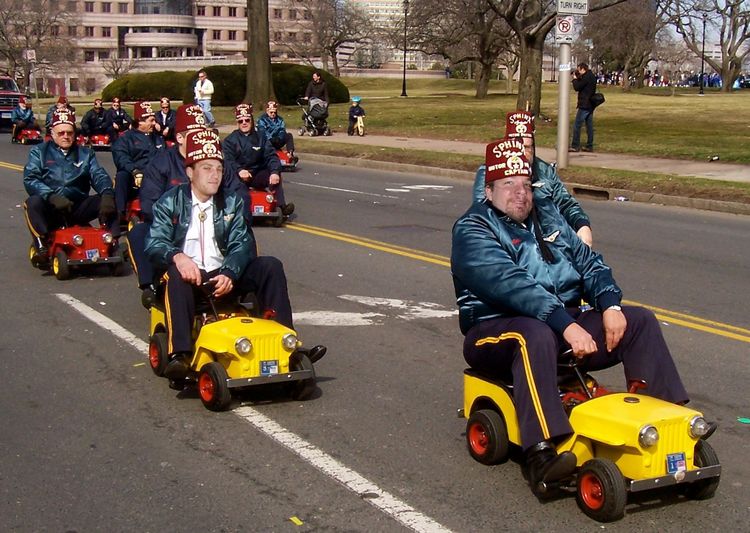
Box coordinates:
[490,0,625,114]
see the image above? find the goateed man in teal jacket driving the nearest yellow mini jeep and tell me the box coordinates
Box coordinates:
[451,138,715,493]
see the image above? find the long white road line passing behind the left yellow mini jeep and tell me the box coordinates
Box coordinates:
[55,294,450,533]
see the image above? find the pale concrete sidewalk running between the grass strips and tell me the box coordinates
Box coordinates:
[300,130,750,183]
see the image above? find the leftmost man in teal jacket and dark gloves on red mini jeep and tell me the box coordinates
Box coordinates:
[23,108,119,266]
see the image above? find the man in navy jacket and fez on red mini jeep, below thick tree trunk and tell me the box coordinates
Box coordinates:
[222,104,294,220]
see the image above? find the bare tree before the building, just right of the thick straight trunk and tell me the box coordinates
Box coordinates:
[275,0,373,76]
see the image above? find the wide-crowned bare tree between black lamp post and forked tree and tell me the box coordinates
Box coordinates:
[408,0,518,98]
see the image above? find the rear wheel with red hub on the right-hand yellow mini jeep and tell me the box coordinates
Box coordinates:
[466,409,510,465]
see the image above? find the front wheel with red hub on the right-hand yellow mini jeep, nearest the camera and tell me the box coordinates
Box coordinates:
[576,459,628,522]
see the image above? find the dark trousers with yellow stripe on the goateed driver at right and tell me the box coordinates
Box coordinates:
[464,307,688,449]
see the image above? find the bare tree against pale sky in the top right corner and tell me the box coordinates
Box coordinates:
[660,0,750,92]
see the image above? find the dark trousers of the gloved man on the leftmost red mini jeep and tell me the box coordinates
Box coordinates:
[23,194,120,238]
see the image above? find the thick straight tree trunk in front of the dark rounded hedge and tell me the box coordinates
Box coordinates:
[245,0,276,107]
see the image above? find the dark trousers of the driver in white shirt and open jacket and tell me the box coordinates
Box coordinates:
[164,257,294,354]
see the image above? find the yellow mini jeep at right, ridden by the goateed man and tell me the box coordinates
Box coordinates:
[459,363,721,522]
